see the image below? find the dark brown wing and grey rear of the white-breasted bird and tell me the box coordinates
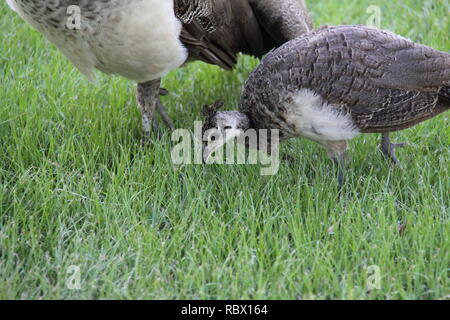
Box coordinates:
[175,0,312,69]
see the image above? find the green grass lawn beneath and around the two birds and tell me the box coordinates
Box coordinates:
[0,0,450,299]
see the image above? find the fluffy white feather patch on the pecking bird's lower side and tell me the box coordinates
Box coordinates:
[285,89,359,143]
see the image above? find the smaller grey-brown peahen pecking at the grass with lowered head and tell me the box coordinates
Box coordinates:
[203,26,450,185]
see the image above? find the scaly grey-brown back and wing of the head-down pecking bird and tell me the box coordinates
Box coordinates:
[255,26,450,130]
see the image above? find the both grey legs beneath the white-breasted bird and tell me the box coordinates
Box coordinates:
[137,79,174,143]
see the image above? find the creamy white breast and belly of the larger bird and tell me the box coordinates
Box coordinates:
[7,0,188,82]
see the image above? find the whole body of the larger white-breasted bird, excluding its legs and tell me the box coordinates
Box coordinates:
[8,0,312,82]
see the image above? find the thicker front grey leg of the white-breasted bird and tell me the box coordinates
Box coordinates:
[137,79,161,143]
